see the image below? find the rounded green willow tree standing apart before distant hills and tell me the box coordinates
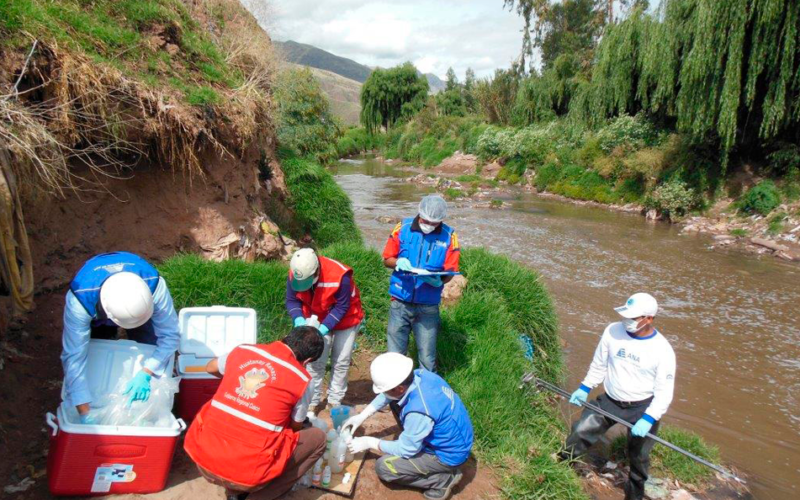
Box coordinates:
[361,62,428,134]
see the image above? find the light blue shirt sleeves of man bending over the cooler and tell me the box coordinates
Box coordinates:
[61,278,181,406]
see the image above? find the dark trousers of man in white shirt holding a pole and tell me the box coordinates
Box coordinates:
[561,394,659,500]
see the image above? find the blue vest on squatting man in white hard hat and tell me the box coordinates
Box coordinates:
[400,370,473,467]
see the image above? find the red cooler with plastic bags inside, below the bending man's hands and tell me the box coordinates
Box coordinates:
[47,340,186,496]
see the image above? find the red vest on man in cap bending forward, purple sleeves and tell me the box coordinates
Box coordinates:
[289,257,364,330]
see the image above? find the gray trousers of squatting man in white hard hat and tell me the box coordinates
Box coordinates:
[375,453,458,490]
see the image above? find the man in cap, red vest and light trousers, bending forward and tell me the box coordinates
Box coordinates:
[286,248,364,412]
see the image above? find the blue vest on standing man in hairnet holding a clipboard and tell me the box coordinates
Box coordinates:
[389,217,453,304]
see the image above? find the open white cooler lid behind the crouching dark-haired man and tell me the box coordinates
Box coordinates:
[178,306,257,358]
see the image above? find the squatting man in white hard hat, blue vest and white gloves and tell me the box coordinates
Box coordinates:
[342,352,473,500]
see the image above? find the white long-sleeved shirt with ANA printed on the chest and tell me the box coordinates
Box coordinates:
[582,323,675,422]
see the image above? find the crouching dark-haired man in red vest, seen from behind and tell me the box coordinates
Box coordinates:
[184,326,325,500]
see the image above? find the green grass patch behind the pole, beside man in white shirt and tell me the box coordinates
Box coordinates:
[611,425,720,486]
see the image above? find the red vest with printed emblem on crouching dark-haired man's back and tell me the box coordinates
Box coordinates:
[183,342,311,486]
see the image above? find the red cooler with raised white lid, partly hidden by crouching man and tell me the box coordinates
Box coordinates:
[177,306,257,422]
